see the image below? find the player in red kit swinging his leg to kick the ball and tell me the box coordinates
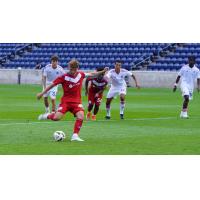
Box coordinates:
[37,59,108,141]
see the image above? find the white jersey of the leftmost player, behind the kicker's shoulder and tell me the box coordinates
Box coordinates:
[42,64,65,85]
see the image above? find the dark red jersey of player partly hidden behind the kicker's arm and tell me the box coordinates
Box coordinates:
[88,78,108,93]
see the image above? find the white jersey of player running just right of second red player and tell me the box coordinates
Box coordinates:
[106,69,132,87]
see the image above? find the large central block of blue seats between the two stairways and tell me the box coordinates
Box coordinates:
[2,43,166,69]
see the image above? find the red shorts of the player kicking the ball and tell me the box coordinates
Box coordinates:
[57,103,84,115]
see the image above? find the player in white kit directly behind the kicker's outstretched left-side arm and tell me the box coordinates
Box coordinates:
[42,55,65,113]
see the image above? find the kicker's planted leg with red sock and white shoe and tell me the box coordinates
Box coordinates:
[71,107,84,142]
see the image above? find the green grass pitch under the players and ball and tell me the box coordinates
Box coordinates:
[0,85,200,155]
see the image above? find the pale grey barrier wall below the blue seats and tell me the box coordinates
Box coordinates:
[0,69,177,88]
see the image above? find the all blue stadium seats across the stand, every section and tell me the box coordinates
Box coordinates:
[0,43,200,70]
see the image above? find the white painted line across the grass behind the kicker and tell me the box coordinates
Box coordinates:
[0,117,178,126]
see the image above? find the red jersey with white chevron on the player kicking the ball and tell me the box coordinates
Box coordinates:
[53,71,85,104]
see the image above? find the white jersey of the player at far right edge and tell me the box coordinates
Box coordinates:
[178,65,200,91]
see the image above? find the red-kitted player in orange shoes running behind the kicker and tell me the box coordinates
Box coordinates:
[85,68,108,121]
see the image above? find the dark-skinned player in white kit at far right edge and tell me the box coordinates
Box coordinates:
[173,56,200,118]
